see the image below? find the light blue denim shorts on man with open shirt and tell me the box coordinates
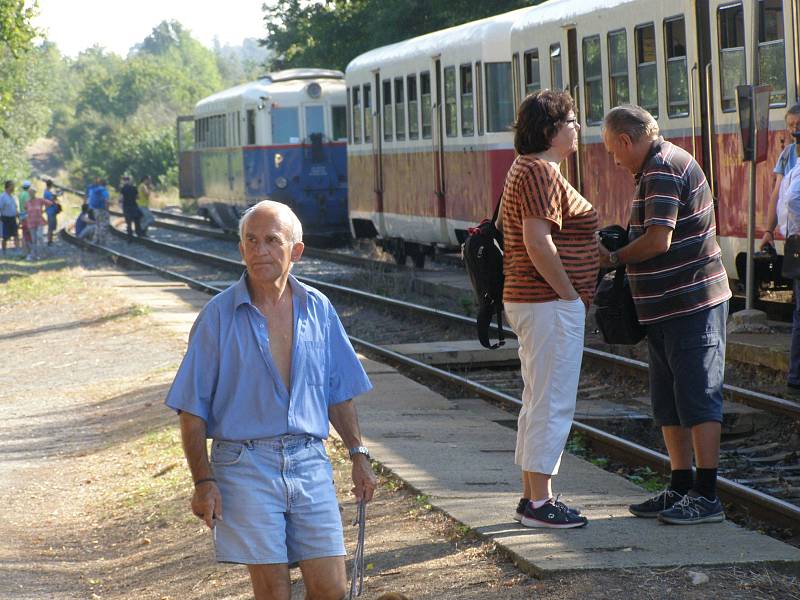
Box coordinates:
[211,435,345,564]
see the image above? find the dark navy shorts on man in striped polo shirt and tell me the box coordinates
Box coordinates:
[647,302,728,427]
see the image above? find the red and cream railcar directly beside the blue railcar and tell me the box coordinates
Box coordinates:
[346,9,530,264]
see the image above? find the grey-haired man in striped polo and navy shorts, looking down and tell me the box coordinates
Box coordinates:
[600,106,731,525]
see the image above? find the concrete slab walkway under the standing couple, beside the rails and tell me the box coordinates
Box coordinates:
[90,269,800,576]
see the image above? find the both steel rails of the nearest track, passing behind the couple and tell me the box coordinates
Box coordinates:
[62,226,800,533]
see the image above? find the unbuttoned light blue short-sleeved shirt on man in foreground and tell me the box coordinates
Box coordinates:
[166,273,372,441]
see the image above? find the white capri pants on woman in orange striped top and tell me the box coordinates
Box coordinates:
[505,298,586,475]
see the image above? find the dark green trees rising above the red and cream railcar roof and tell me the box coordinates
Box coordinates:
[261,0,541,70]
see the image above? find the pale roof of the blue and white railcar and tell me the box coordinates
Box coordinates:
[194,69,344,116]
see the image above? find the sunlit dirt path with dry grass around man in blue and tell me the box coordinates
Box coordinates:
[0,248,800,600]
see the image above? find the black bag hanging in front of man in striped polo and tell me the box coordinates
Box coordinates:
[594,265,646,345]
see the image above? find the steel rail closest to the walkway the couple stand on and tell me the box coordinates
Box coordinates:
[61,229,800,528]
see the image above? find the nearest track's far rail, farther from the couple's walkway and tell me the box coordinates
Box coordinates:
[112,228,800,419]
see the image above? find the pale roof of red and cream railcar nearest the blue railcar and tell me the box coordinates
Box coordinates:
[345,7,535,73]
